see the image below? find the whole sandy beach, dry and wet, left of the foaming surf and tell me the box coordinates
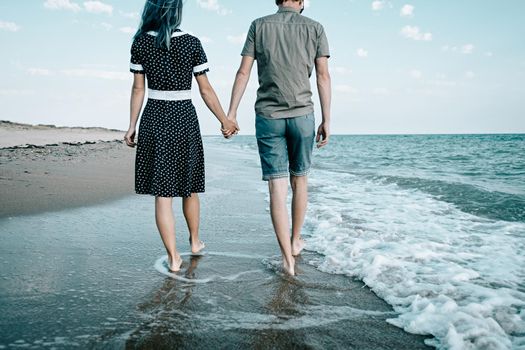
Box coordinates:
[0,121,426,349]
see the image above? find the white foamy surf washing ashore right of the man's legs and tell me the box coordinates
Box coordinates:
[306,170,525,349]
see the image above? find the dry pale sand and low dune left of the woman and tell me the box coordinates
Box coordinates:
[0,121,135,218]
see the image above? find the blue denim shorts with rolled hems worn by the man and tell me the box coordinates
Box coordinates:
[255,113,315,181]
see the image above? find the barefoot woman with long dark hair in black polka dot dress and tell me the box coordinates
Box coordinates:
[124,0,238,271]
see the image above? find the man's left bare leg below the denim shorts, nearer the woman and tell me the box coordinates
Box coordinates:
[268,178,295,276]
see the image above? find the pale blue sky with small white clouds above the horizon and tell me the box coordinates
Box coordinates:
[0,0,525,135]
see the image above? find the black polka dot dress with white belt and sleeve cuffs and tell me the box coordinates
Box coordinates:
[130,30,209,197]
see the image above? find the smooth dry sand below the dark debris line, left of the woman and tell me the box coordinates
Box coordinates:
[0,141,135,218]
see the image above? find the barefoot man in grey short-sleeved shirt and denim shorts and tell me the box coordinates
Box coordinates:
[228,0,331,275]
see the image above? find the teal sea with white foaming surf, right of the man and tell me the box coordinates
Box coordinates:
[224,135,525,349]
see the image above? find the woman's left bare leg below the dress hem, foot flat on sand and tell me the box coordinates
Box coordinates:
[155,197,182,271]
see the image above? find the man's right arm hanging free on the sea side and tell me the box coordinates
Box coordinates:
[315,57,332,148]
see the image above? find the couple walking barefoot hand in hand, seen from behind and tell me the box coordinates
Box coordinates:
[124,0,331,275]
